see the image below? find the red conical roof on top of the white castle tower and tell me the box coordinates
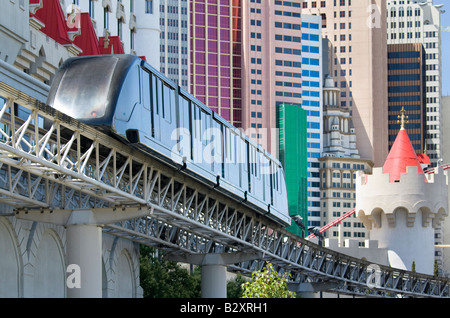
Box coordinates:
[383,128,423,182]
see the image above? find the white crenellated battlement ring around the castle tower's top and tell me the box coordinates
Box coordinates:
[356,167,448,230]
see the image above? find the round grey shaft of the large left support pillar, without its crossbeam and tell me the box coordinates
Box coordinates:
[66,224,102,298]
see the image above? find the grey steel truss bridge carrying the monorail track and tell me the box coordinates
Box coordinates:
[0,83,450,297]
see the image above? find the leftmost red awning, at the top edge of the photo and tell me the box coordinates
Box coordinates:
[35,0,72,44]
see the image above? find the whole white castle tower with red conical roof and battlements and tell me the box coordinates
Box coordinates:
[356,112,448,274]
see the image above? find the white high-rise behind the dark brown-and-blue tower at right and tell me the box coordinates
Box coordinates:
[387,0,442,165]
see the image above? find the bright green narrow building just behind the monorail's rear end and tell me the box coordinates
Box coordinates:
[277,104,308,236]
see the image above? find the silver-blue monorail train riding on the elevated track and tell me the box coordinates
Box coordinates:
[47,54,291,226]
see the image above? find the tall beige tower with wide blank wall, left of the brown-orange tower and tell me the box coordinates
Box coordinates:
[302,0,388,167]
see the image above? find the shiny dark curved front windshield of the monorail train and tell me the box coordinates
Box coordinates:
[52,57,118,119]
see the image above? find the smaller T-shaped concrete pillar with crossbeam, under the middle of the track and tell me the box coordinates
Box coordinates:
[167,253,262,298]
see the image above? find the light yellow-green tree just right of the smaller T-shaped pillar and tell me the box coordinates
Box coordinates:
[242,262,295,298]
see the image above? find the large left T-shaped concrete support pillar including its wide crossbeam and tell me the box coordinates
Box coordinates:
[15,207,151,298]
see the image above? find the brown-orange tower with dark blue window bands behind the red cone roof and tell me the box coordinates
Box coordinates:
[388,43,426,154]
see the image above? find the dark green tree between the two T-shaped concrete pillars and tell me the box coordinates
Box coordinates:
[140,245,201,298]
